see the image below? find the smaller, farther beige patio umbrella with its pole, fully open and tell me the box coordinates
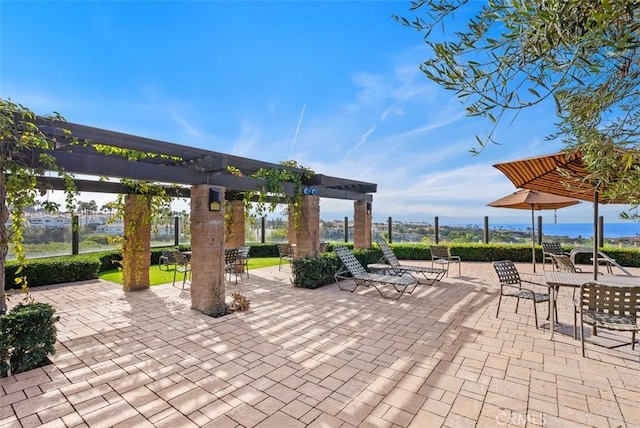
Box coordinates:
[487,189,580,272]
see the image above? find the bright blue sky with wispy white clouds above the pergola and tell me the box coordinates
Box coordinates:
[0,0,638,231]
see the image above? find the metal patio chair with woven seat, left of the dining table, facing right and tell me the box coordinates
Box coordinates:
[493,260,558,329]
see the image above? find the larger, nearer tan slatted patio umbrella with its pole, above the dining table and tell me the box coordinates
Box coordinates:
[493,152,627,280]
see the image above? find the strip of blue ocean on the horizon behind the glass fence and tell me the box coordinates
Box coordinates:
[478,222,640,238]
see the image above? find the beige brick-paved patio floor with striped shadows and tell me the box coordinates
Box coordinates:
[0,263,640,428]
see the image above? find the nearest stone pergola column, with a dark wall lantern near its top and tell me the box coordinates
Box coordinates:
[191,185,225,313]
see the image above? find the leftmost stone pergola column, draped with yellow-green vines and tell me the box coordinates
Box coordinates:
[122,195,151,291]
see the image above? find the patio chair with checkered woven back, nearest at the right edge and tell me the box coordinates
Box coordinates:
[574,282,640,357]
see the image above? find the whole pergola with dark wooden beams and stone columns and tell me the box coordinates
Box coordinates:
[21,117,377,312]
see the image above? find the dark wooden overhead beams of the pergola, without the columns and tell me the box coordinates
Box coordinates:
[36,118,377,202]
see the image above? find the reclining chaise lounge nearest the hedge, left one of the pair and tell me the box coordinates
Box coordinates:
[333,247,418,300]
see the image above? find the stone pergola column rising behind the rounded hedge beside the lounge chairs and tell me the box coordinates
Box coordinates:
[289,195,320,257]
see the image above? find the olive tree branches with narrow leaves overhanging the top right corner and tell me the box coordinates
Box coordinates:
[394,0,640,211]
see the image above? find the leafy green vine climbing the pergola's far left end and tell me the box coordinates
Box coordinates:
[0,99,77,313]
